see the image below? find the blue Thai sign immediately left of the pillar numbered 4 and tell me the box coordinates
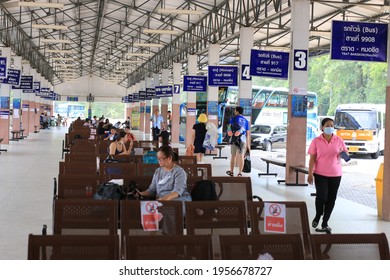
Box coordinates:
[208,65,238,86]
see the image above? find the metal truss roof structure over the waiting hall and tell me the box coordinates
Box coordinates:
[0,0,390,92]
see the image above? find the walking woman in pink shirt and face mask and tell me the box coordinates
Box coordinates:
[307,118,348,232]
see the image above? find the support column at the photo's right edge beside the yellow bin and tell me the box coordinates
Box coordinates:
[382,21,390,221]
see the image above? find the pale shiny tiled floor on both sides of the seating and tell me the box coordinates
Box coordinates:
[0,127,390,260]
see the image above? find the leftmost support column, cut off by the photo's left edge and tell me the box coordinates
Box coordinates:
[0,48,11,144]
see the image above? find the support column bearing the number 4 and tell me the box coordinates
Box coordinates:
[238,27,254,142]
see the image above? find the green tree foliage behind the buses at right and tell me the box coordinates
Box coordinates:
[253,55,387,116]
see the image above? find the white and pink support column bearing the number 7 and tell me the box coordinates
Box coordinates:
[171,63,181,143]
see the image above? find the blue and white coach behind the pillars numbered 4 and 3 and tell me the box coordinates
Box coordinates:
[219,86,318,141]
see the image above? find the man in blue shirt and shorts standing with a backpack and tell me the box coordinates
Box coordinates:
[226,107,250,177]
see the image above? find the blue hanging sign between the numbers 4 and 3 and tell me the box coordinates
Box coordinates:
[250,50,290,80]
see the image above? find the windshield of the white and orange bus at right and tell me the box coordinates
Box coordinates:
[334,111,377,130]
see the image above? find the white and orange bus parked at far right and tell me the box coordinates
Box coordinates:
[335,104,386,159]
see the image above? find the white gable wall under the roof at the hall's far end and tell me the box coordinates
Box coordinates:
[54,75,126,102]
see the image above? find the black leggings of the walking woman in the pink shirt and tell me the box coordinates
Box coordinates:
[314,173,341,227]
